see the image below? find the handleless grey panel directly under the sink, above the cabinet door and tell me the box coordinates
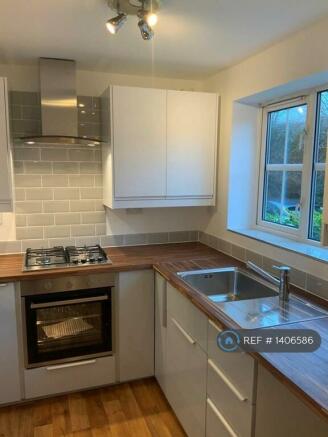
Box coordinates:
[167,284,207,351]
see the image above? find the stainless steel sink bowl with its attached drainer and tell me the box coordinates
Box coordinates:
[177,267,328,329]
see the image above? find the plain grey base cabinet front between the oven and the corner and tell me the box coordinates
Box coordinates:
[114,270,154,381]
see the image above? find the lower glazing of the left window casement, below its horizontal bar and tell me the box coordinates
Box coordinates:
[263,171,302,229]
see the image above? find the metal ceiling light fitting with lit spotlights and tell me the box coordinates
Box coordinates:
[106,0,159,41]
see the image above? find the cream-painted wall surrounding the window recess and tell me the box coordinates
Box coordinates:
[204,19,328,278]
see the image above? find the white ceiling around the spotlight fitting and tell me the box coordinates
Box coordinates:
[0,0,328,79]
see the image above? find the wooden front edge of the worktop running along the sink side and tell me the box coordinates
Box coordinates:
[153,264,328,421]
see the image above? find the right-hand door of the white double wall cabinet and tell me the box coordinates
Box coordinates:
[167,91,218,197]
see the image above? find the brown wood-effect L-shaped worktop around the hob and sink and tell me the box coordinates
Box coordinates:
[0,243,328,420]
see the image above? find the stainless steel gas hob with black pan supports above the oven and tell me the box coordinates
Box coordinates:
[23,244,112,272]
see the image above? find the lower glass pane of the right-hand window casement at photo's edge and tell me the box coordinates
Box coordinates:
[309,171,325,241]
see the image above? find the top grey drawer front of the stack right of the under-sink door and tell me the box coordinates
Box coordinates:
[207,322,256,402]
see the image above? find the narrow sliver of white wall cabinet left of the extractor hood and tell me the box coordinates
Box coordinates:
[0,78,13,212]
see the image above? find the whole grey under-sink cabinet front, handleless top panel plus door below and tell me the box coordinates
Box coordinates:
[164,284,207,437]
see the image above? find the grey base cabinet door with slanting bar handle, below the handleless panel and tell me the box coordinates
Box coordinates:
[166,315,207,437]
